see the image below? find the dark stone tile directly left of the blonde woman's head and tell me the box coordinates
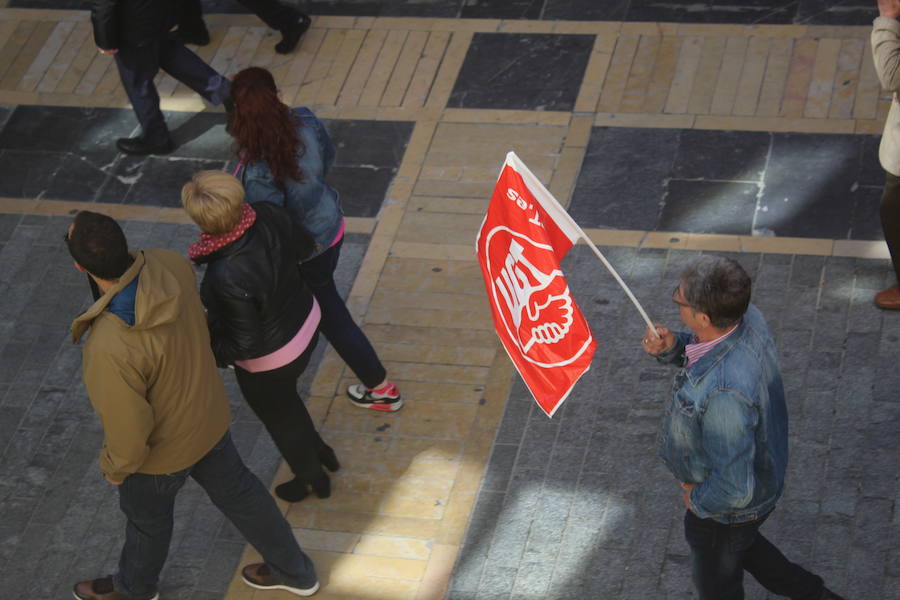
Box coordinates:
[123,156,225,207]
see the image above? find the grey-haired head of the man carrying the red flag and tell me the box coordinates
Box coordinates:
[680,255,750,329]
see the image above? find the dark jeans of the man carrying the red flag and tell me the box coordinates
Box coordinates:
[684,511,824,600]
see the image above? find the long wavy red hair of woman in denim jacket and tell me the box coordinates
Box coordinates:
[228,67,304,187]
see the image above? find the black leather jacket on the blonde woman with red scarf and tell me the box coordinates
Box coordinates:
[195,202,313,366]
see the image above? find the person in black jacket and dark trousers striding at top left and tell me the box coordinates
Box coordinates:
[91,0,231,154]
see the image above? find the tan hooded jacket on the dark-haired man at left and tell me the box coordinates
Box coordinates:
[72,250,230,481]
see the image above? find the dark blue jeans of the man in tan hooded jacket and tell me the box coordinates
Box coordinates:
[113,432,316,600]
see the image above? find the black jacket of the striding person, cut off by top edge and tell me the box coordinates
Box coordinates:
[91,0,175,50]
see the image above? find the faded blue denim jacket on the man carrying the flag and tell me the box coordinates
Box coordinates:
[657,304,788,523]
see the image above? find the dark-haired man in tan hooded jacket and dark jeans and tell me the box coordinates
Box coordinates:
[66,211,318,600]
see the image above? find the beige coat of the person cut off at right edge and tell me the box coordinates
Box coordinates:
[872,17,900,177]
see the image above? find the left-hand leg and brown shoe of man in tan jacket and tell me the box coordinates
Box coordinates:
[74,469,190,600]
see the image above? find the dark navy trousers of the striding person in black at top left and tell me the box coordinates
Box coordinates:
[115,35,231,144]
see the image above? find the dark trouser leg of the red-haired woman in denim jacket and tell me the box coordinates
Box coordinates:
[300,239,387,388]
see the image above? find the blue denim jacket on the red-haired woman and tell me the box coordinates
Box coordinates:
[240,107,344,260]
